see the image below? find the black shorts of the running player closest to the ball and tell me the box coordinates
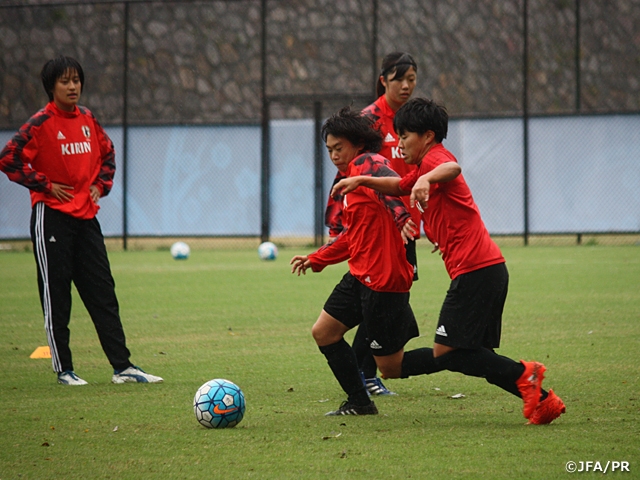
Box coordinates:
[324,273,419,356]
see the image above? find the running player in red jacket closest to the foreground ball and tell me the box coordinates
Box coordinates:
[291,107,418,415]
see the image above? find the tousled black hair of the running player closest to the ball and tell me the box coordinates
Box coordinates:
[321,105,382,153]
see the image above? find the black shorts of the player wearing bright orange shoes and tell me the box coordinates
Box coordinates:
[434,263,509,348]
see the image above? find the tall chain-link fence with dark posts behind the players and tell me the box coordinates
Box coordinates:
[0,0,640,248]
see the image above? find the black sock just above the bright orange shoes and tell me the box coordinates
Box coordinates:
[436,348,524,397]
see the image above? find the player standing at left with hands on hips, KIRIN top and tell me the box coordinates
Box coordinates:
[0,56,162,385]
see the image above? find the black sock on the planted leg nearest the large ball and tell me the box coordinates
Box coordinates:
[319,338,371,406]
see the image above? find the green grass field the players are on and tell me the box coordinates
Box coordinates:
[0,246,640,480]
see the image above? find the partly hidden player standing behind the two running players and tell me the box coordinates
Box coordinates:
[325,52,420,395]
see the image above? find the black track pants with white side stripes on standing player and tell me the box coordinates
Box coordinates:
[31,203,131,372]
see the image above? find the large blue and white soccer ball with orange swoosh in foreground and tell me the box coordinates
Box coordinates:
[193,378,246,428]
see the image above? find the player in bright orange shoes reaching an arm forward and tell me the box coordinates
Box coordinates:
[334,98,565,424]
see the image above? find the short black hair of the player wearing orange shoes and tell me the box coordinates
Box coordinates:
[393,98,449,143]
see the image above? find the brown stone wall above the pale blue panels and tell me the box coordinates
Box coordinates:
[0,0,640,128]
